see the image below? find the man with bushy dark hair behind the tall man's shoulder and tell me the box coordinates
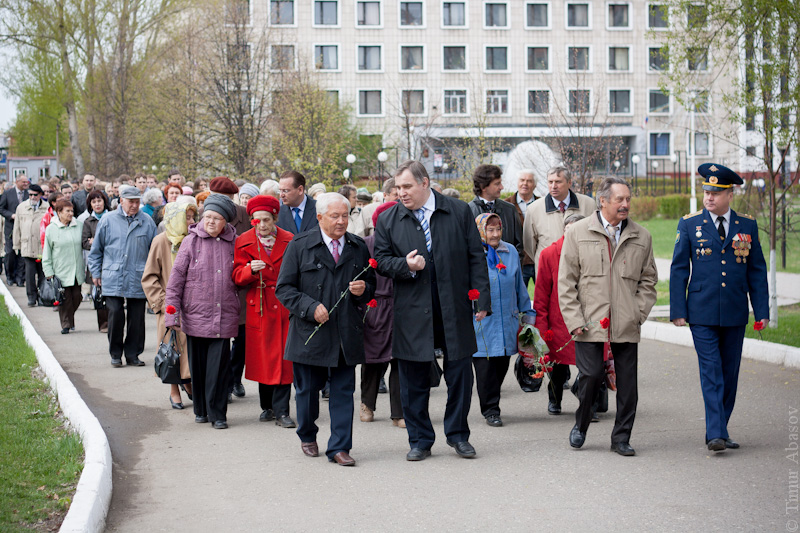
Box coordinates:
[469,165,525,261]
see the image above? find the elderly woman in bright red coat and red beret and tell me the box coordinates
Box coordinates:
[233,195,296,428]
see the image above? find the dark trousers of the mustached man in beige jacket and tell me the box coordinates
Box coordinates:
[575,342,639,443]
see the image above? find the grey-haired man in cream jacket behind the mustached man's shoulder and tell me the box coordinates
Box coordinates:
[522,165,595,276]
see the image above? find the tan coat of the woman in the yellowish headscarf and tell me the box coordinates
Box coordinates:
[142,233,191,379]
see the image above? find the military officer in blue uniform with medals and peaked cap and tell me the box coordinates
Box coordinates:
[669,163,769,452]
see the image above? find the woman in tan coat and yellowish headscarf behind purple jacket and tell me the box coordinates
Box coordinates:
[142,202,197,409]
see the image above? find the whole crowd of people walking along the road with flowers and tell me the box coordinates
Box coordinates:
[0,161,767,466]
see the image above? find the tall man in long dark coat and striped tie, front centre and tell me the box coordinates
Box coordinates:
[375,161,494,461]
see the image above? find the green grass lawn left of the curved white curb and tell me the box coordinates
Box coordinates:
[0,297,83,531]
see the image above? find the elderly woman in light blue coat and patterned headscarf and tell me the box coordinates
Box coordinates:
[472,213,536,427]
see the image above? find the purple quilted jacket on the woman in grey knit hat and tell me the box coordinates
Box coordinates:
[165,222,239,339]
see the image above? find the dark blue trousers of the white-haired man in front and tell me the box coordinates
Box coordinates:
[292,353,356,459]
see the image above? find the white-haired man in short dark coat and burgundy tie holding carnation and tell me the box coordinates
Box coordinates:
[275,192,375,466]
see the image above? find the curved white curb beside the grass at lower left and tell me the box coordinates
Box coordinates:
[0,282,112,532]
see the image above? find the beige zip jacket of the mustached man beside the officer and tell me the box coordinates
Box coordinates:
[558,213,658,342]
